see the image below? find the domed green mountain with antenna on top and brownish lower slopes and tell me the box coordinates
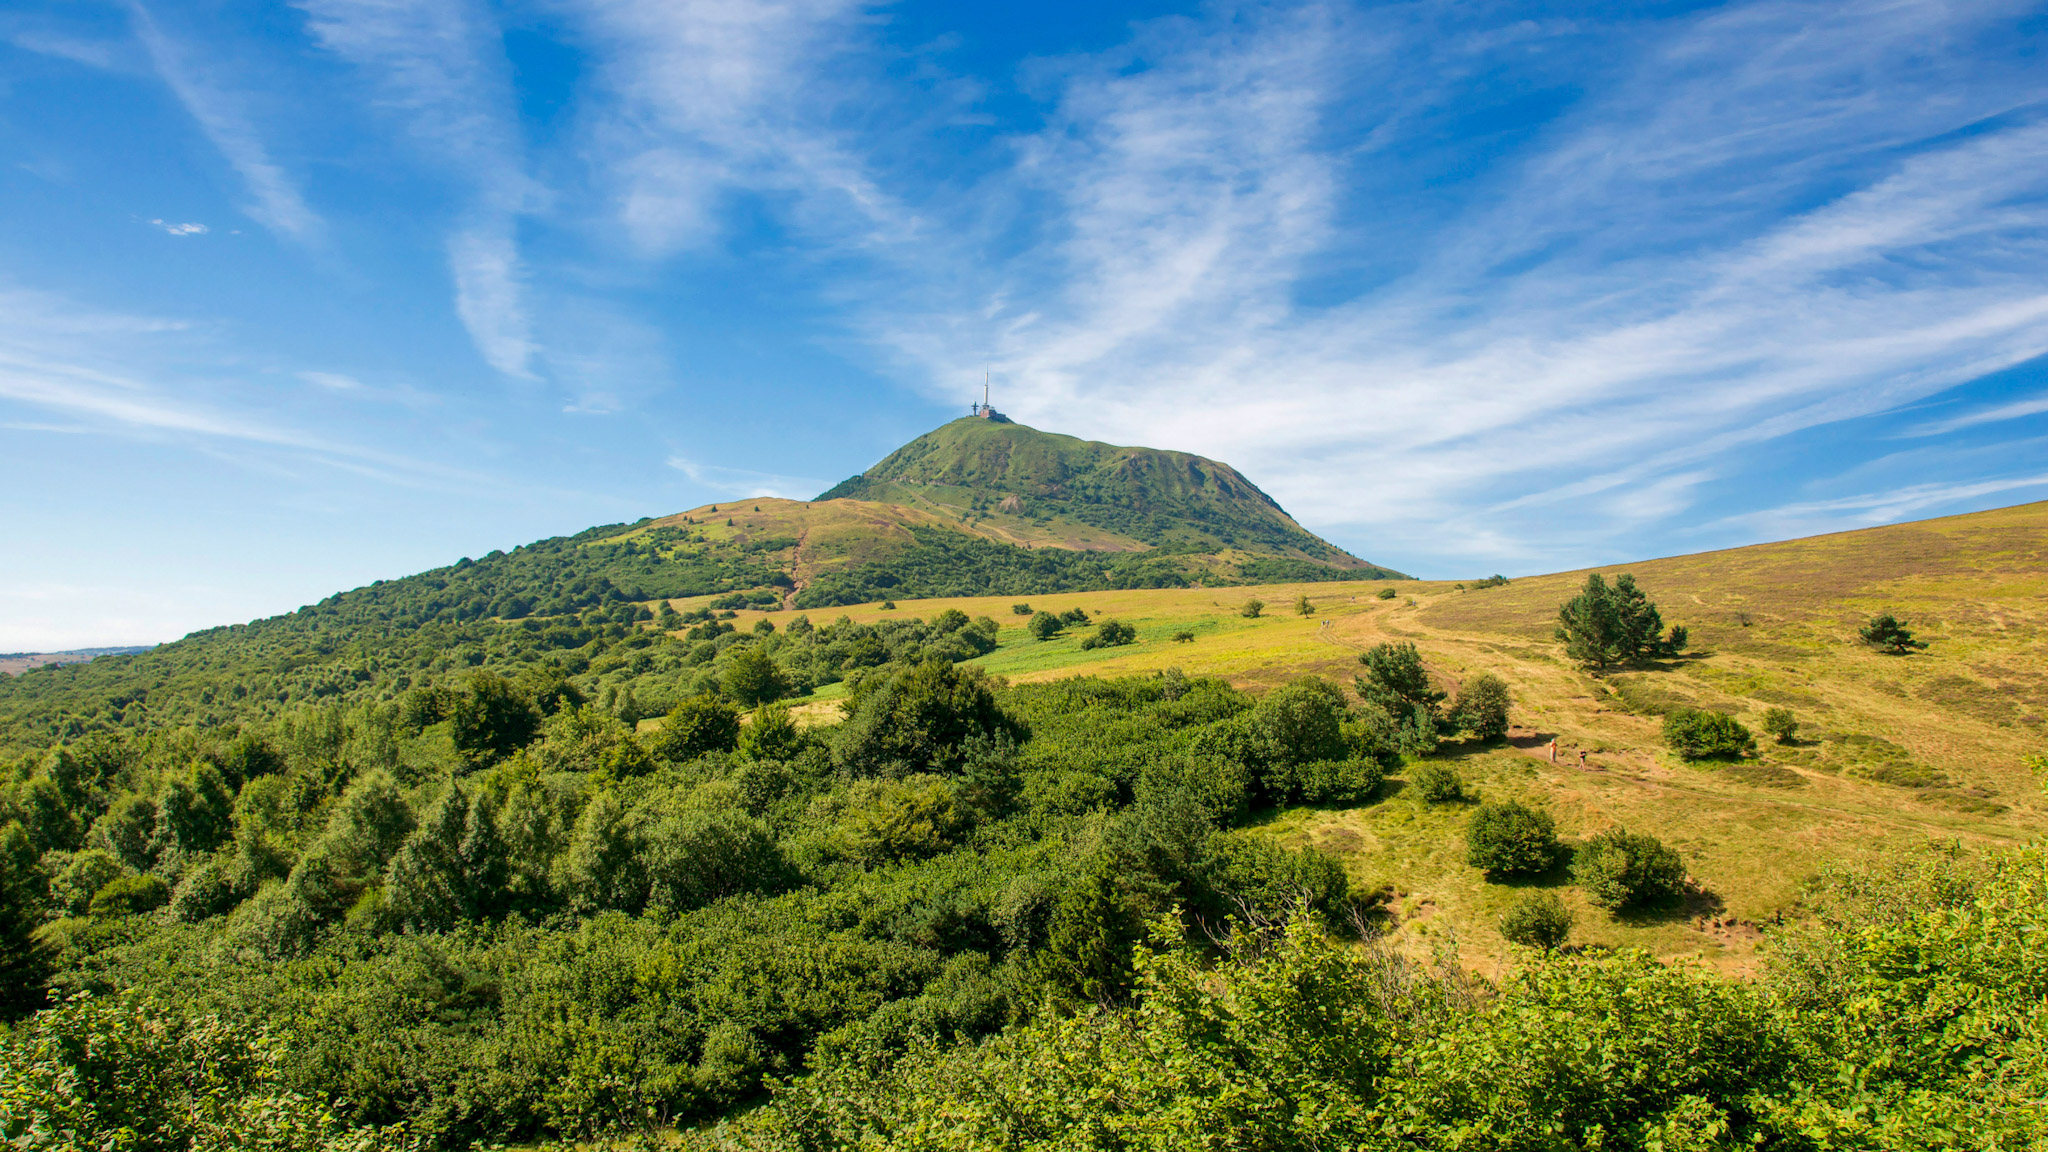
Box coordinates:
[604,414,1401,609]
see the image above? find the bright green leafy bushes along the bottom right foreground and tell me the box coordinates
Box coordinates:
[698,849,2048,1152]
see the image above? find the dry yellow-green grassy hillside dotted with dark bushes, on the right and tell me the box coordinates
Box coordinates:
[708,504,2048,968]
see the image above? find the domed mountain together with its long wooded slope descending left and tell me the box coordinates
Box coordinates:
[0,420,1395,750]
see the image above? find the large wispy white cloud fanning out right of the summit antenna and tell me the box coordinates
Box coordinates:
[823,4,2048,566]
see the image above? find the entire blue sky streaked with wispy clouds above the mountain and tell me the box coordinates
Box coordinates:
[0,0,2048,650]
